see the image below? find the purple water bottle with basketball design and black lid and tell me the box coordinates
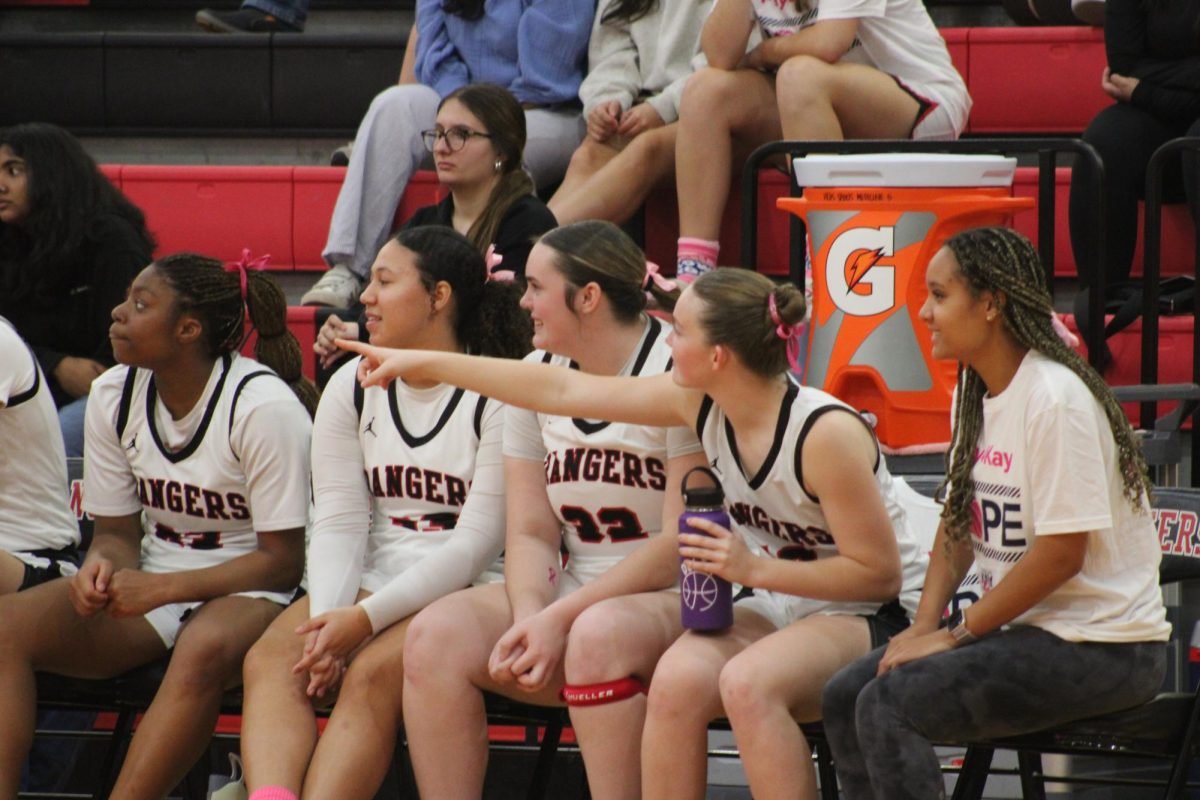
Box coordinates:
[679,467,733,631]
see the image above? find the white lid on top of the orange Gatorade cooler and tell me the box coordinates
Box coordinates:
[792,152,1016,188]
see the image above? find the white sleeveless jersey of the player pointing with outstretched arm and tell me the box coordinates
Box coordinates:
[696,381,925,615]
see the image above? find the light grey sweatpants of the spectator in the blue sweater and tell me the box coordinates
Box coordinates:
[323,84,586,278]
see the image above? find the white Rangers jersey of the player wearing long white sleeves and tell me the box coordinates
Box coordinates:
[354,359,503,591]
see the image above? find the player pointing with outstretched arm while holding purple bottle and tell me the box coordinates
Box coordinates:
[352,263,924,798]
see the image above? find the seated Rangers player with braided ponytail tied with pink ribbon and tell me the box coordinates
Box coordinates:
[0,254,316,800]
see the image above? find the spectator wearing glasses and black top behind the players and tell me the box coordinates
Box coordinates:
[313,84,556,379]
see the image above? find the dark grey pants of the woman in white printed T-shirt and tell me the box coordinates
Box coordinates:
[822,626,1166,800]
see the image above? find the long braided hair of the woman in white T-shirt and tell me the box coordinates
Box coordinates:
[938,228,1151,541]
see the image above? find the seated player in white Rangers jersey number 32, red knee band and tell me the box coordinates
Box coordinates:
[404,222,703,798]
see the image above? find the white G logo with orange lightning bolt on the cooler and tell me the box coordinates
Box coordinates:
[826,225,896,317]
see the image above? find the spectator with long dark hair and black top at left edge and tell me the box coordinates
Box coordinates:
[0,122,155,456]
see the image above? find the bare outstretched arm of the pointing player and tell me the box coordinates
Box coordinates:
[337,339,703,427]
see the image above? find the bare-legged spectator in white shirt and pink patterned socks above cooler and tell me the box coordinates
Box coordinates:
[676,0,971,281]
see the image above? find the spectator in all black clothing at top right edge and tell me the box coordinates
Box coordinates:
[1069,0,1200,359]
